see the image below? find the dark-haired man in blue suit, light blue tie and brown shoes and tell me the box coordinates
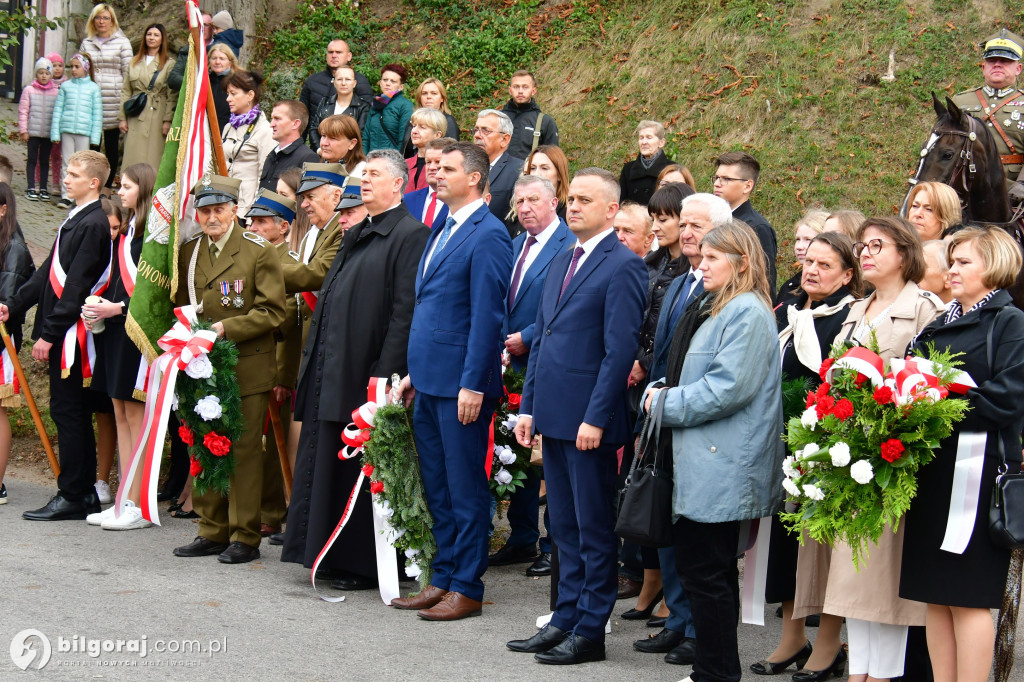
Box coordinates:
[391,142,512,621]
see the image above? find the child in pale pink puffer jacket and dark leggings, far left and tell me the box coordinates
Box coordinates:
[17,57,58,201]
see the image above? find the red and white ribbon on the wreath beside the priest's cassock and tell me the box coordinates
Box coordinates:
[309,377,400,605]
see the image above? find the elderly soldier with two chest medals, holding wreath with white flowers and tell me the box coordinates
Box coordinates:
[174,173,285,563]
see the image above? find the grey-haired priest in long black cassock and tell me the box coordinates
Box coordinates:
[282,150,430,590]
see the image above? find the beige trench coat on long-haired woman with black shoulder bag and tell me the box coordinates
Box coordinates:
[118,57,175,170]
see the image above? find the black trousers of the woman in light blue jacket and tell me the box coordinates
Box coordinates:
[674,518,742,682]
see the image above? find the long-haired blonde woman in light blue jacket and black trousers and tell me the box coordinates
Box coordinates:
[646,220,784,682]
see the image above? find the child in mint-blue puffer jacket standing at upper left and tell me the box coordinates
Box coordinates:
[50,54,103,209]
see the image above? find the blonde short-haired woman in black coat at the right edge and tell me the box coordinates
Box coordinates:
[899,227,1024,680]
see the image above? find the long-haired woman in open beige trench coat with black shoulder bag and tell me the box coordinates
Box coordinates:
[118,24,175,169]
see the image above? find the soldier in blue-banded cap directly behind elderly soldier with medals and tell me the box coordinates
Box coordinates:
[246,189,302,537]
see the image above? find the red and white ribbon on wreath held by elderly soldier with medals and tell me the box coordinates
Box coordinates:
[115,306,217,525]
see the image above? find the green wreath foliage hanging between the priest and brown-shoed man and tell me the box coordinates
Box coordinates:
[362,404,437,588]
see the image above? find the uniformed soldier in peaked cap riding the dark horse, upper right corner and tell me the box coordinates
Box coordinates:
[952,29,1024,183]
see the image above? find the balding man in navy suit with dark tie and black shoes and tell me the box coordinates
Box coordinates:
[507,168,647,665]
